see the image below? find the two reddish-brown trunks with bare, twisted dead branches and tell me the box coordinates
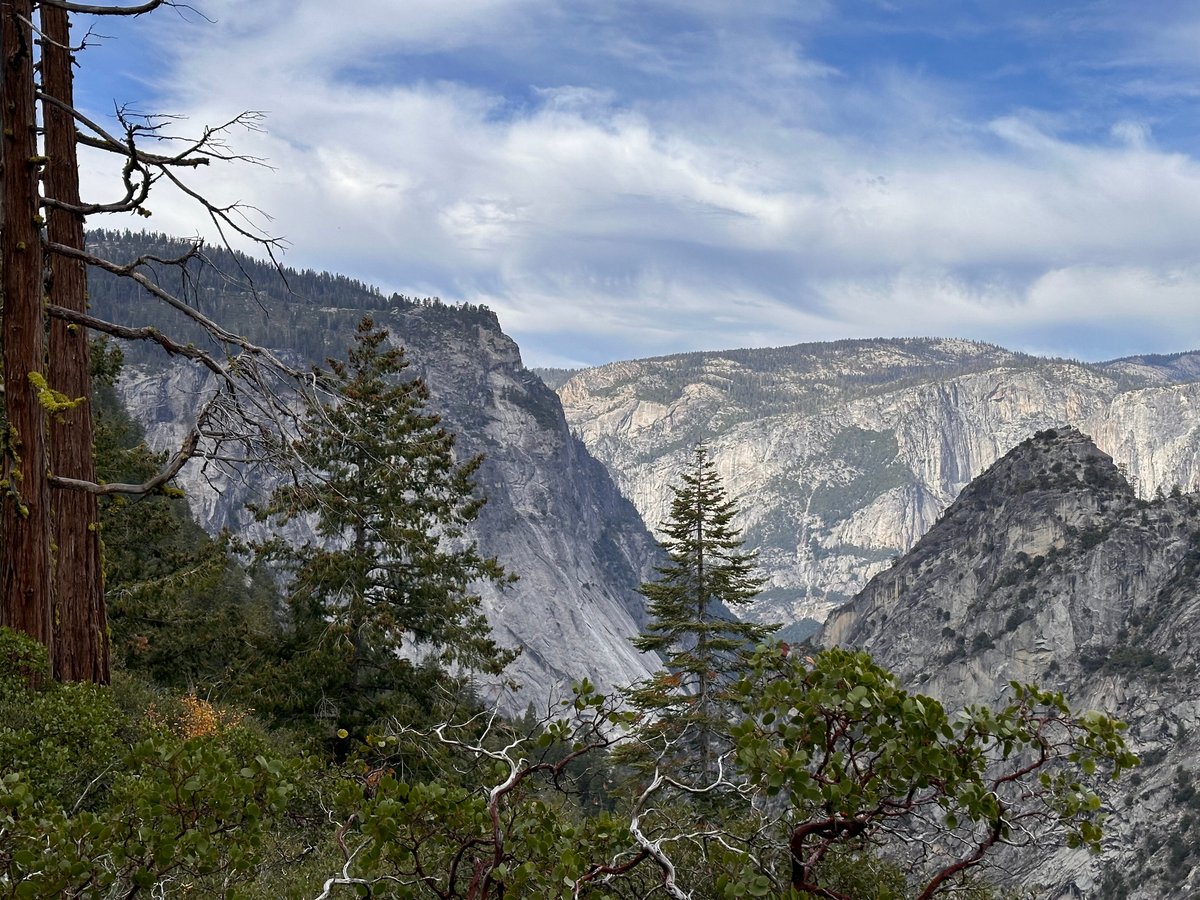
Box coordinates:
[0,0,302,684]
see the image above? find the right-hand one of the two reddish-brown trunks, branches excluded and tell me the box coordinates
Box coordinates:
[42,6,109,684]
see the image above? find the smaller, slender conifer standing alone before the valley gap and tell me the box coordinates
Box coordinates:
[629,444,779,782]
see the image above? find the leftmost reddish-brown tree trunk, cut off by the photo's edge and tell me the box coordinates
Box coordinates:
[0,0,54,659]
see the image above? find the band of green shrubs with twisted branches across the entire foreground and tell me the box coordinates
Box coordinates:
[0,630,1136,900]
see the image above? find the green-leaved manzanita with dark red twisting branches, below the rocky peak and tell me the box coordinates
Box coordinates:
[733,647,1138,898]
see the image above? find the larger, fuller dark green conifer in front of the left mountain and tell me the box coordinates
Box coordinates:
[258,318,516,728]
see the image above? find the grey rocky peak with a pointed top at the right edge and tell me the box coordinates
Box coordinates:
[818,428,1200,900]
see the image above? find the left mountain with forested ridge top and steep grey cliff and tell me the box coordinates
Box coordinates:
[89,232,658,712]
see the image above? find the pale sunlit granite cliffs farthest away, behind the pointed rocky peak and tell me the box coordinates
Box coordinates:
[559,340,1200,623]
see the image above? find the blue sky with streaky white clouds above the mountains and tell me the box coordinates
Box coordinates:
[76,0,1200,366]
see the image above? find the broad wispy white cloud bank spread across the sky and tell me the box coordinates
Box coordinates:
[77,0,1200,360]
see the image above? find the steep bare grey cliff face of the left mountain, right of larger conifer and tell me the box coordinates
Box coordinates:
[386,308,659,702]
